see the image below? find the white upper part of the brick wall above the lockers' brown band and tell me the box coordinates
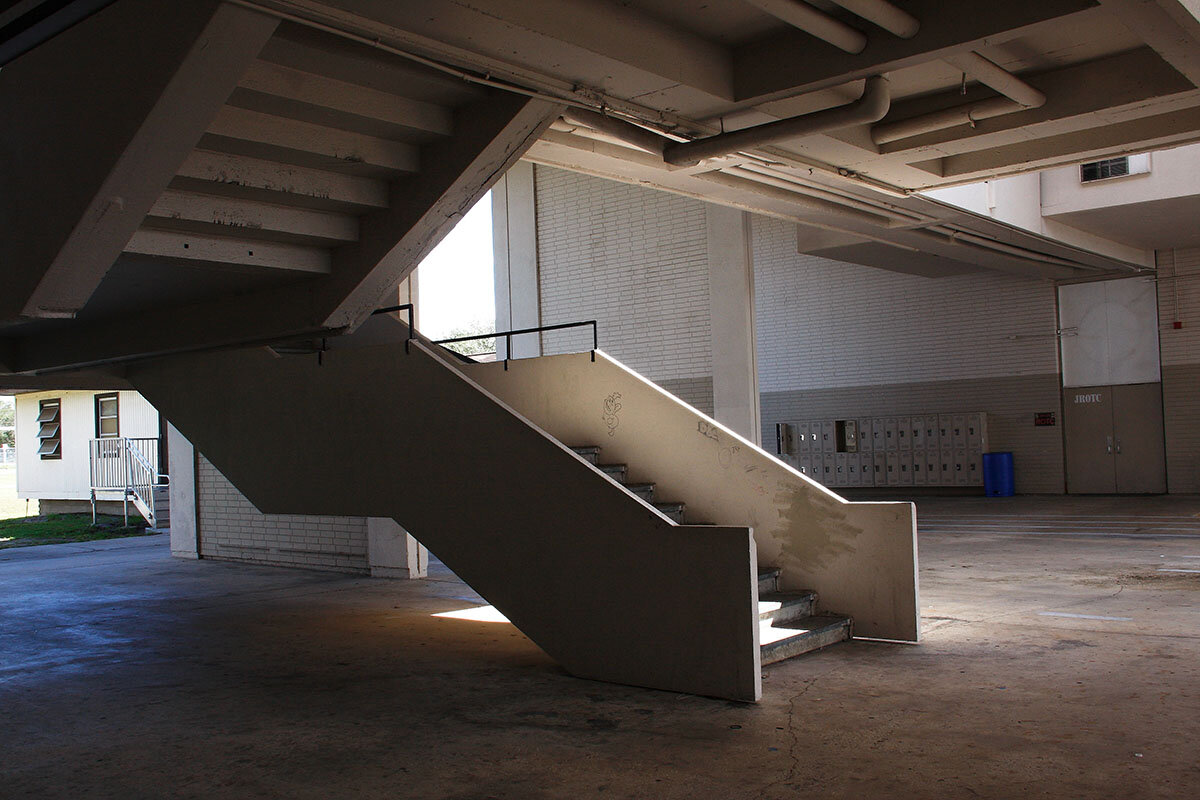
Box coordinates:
[754,217,1058,392]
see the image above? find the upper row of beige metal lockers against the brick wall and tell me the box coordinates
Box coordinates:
[775,413,988,456]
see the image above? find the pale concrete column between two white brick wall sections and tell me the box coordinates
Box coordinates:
[704,205,762,444]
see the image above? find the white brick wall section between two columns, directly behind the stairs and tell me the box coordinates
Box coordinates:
[536,167,713,383]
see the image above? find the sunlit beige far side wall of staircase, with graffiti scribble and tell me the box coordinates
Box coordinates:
[462,351,918,642]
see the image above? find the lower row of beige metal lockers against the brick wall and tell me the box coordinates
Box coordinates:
[781,450,983,487]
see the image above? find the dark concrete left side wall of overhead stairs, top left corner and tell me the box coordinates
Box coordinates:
[0,0,276,318]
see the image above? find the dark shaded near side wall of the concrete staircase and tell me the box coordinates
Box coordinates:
[128,331,761,700]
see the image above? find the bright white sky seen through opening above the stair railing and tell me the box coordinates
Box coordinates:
[416,192,496,338]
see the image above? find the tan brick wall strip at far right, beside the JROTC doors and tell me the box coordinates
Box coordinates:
[1156,247,1200,493]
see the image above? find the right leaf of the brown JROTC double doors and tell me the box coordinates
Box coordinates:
[1112,384,1166,494]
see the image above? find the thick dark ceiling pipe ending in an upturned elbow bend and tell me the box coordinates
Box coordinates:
[662,76,892,167]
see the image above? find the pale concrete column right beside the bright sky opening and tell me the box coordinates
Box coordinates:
[492,161,541,359]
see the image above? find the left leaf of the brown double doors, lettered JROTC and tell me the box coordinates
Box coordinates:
[1062,386,1117,494]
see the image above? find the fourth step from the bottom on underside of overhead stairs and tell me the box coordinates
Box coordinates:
[200,106,420,175]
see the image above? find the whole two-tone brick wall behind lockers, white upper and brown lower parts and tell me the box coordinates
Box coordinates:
[754,217,1063,493]
